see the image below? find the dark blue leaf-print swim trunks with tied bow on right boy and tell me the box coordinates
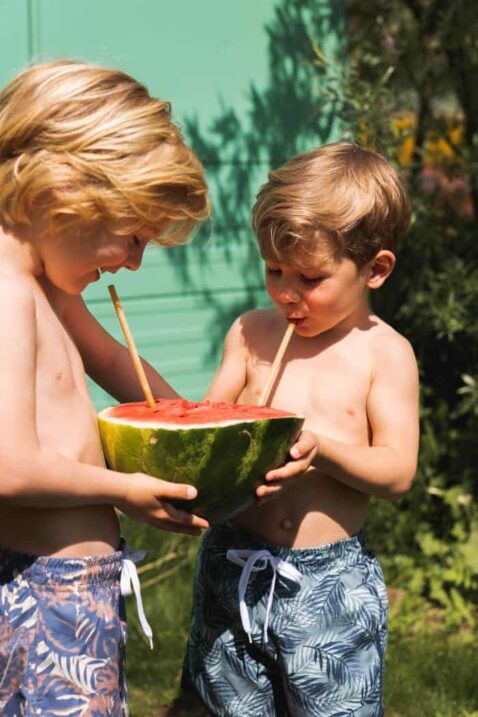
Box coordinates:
[183,523,387,717]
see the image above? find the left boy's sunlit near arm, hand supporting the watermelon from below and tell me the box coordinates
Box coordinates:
[0,278,207,534]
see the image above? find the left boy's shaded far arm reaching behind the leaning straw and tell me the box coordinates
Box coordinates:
[62,296,178,403]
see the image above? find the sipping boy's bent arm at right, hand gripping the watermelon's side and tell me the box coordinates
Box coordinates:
[264,336,419,499]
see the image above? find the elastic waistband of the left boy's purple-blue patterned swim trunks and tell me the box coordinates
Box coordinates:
[0,541,124,589]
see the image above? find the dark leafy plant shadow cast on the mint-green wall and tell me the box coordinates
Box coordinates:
[166,0,346,366]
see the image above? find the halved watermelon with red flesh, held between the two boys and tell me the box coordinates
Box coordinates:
[98,399,304,521]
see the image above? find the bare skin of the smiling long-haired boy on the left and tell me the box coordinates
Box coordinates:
[0,225,207,557]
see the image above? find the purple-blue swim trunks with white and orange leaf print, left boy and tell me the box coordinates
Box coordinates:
[0,547,128,717]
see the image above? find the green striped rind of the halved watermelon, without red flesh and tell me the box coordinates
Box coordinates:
[98,409,304,522]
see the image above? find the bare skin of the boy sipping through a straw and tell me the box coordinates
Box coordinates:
[207,250,418,547]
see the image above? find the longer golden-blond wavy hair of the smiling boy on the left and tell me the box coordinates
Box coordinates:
[0,60,209,245]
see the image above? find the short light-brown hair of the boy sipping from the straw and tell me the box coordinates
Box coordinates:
[252,142,410,267]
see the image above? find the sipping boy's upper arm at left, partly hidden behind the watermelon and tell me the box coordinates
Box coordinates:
[205,317,246,403]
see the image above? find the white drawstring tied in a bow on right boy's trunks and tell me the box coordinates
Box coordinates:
[226,549,304,642]
